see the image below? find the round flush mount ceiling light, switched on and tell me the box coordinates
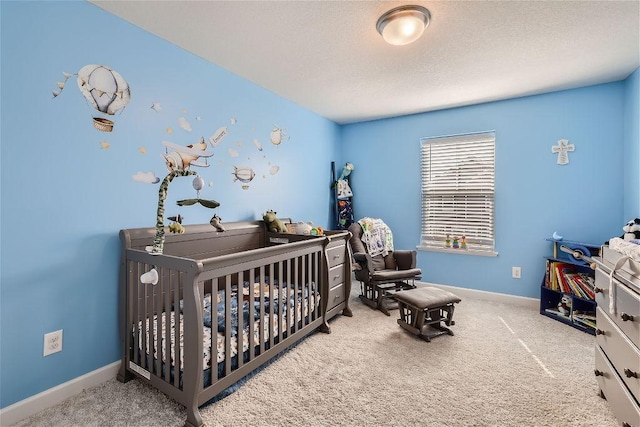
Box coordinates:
[376,6,431,45]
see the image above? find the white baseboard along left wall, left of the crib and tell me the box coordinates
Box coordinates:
[0,361,120,426]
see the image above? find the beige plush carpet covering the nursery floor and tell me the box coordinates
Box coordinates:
[12,282,616,427]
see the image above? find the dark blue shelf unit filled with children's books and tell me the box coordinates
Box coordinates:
[540,239,600,335]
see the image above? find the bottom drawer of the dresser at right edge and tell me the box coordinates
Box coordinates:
[595,346,640,427]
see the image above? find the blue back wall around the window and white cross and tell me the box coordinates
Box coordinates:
[342,82,626,297]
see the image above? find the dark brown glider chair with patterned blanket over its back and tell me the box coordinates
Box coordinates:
[349,220,422,316]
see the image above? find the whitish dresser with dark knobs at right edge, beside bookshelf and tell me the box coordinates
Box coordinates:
[594,246,640,427]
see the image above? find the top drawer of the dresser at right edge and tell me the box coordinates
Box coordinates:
[596,268,640,350]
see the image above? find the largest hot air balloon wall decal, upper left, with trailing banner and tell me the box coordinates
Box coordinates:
[53,64,131,132]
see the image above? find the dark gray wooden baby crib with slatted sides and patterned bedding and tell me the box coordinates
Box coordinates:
[118,221,351,426]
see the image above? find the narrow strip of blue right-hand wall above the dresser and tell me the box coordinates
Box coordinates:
[623,68,640,223]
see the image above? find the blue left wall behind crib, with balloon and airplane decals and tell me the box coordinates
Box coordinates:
[0,1,340,407]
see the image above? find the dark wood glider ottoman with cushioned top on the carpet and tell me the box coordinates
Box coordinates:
[394,287,461,341]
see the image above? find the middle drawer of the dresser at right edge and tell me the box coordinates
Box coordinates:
[596,307,640,400]
